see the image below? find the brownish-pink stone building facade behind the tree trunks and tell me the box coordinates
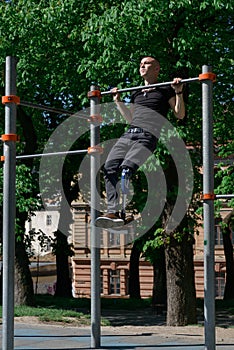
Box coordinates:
[72,203,231,298]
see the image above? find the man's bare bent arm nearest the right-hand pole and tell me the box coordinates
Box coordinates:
[169,78,185,119]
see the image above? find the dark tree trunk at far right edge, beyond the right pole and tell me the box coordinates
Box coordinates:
[223,227,234,300]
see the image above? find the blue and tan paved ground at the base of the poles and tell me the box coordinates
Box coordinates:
[1,322,234,350]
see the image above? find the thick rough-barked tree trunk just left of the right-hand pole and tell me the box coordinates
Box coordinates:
[165,236,197,326]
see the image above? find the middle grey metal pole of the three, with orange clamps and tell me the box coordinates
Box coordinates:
[90,85,101,349]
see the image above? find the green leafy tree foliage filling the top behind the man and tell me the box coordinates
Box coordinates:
[0,0,234,312]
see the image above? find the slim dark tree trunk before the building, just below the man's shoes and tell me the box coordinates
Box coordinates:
[129,242,141,299]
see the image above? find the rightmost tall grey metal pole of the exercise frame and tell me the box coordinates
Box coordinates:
[202,66,216,350]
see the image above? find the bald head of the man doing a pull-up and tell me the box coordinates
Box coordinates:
[140,56,160,84]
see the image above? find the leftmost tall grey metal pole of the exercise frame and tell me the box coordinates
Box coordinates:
[2,56,16,350]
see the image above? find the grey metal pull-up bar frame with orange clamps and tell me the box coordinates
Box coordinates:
[2,56,234,350]
